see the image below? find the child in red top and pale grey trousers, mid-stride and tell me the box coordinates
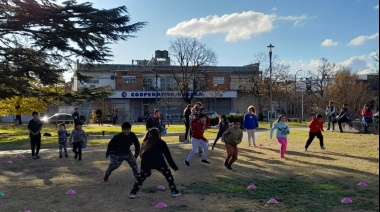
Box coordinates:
[185,114,210,166]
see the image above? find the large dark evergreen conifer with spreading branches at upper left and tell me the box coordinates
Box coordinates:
[0,0,146,102]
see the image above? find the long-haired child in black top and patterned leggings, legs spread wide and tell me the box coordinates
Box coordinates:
[129,127,181,199]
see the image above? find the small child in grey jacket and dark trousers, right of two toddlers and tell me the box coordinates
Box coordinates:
[70,121,87,160]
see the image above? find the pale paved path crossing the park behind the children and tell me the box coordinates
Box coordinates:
[0,129,268,155]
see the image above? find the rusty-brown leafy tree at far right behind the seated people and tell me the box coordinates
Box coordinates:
[329,68,378,118]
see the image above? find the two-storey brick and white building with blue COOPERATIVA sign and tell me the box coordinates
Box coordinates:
[72,51,260,120]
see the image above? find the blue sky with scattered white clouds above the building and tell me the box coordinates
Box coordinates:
[65,0,379,79]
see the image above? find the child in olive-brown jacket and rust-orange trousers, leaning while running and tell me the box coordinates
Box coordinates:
[222,120,243,170]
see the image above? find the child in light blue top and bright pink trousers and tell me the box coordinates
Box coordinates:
[270,114,290,158]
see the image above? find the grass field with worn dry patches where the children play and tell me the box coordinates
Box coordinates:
[0,121,379,212]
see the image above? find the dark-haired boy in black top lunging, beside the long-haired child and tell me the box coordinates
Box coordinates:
[103,122,140,182]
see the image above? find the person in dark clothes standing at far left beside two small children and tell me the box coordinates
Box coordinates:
[28,111,42,159]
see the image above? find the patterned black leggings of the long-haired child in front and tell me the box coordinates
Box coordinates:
[131,167,177,194]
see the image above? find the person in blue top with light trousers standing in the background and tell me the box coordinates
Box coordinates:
[243,105,259,146]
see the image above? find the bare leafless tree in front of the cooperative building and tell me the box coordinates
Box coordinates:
[169,37,217,104]
